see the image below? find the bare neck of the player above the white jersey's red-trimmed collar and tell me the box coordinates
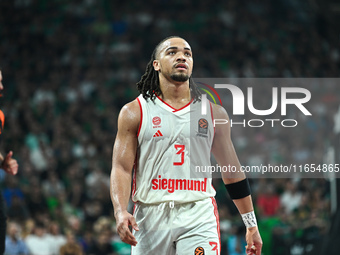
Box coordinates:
[159,75,191,109]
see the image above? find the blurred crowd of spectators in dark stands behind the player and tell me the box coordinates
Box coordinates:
[0,0,340,255]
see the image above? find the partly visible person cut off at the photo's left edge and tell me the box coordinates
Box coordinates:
[0,70,18,254]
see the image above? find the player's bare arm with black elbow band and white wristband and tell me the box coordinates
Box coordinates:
[212,105,262,255]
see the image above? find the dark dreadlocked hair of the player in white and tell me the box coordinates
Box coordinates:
[136,36,202,102]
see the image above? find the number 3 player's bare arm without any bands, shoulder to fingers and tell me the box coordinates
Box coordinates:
[110,100,141,246]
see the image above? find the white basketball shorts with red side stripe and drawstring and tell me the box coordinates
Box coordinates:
[131,198,221,255]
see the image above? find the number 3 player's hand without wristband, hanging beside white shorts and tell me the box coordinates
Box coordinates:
[115,211,139,246]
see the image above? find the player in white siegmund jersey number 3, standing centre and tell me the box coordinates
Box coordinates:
[110,36,262,255]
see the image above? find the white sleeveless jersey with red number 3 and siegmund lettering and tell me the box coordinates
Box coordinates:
[132,95,215,204]
